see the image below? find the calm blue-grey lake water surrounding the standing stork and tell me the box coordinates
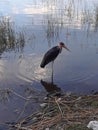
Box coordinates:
[0,0,98,123]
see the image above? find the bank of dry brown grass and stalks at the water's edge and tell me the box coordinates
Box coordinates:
[9,95,98,130]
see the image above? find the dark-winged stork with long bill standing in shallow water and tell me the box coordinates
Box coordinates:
[40,42,70,83]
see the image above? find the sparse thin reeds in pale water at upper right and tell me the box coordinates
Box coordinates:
[42,0,98,43]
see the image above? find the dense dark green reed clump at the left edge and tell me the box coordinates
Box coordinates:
[0,17,25,54]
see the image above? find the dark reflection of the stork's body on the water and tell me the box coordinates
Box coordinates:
[41,80,61,96]
